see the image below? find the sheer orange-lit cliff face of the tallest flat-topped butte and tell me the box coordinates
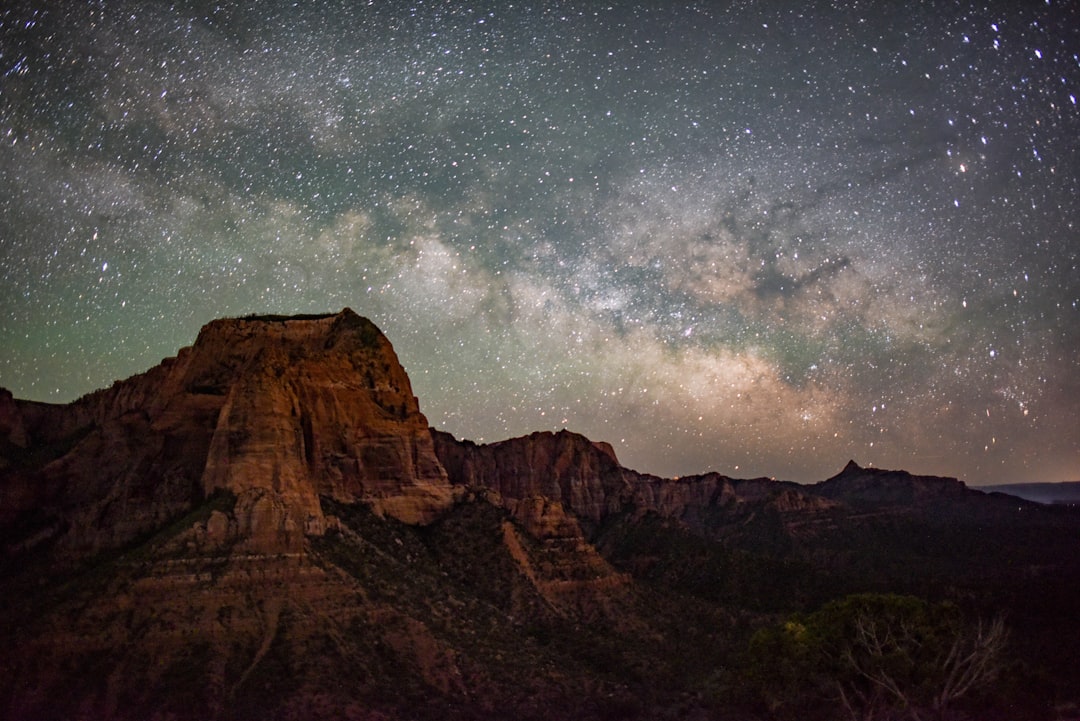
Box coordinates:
[186,310,454,542]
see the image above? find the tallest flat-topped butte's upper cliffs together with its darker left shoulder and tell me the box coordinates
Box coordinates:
[0,309,454,555]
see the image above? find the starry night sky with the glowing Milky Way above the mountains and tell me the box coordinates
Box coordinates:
[0,0,1080,485]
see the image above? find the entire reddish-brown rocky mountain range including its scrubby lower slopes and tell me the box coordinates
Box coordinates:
[0,309,1080,719]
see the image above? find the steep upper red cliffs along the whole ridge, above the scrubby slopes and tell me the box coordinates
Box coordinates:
[0,309,959,558]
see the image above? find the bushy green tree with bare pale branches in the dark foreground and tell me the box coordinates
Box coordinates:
[747,594,1007,721]
